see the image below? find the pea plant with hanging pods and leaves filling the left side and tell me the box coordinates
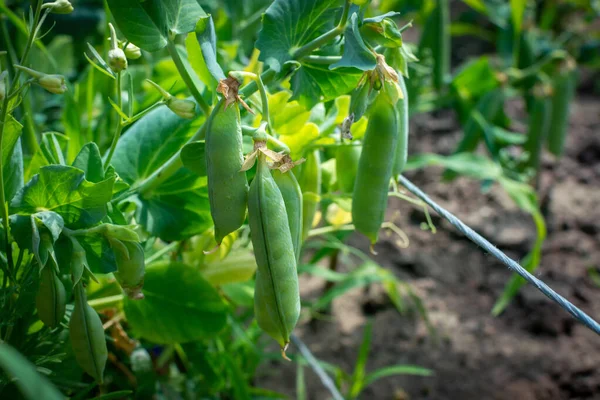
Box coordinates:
[0,0,597,399]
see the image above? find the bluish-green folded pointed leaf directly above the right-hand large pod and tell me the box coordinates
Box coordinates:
[329,13,377,71]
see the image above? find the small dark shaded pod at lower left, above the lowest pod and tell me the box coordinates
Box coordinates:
[35,262,67,328]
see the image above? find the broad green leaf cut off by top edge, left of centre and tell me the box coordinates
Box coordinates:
[108,0,206,51]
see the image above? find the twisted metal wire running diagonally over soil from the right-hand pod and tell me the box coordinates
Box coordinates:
[399,176,600,335]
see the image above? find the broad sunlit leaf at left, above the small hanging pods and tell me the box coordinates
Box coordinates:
[10,165,115,229]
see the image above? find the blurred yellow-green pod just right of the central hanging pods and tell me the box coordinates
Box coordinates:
[298,150,321,241]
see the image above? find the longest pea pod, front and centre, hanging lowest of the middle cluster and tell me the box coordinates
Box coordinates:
[248,154,300,357]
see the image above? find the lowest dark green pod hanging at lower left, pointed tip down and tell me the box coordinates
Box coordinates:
[69,281,108,383]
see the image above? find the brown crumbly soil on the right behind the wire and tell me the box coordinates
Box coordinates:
[257,98,600,400]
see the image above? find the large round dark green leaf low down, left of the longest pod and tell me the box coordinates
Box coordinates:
[124,262,227,344]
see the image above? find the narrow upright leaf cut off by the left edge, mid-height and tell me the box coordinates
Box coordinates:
[2,115,23,200]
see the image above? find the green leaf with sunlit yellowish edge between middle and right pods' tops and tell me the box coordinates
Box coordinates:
[292,63,362,109]
